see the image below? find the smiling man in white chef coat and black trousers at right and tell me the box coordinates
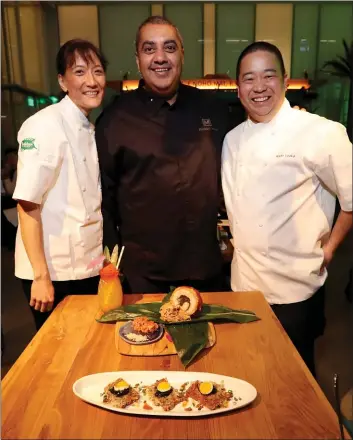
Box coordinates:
[222,42,352,375]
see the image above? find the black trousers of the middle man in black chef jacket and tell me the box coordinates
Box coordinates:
[123,273,228,293]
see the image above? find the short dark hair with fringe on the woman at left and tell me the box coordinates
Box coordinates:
[56,38,108,75]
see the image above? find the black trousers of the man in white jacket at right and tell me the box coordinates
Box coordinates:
[271,286,326,377]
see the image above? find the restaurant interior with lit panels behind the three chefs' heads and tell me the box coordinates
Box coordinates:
[1,1,353,146]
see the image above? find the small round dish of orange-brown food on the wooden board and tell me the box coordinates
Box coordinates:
[119,316,164,345]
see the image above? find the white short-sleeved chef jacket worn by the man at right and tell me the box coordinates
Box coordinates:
[222,100,352,304]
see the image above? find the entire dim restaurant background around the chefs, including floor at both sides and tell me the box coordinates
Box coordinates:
[1,1,353,418]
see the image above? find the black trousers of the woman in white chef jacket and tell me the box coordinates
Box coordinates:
[21,276,99,331]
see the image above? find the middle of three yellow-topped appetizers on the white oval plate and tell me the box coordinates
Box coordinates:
[145,378,185,411]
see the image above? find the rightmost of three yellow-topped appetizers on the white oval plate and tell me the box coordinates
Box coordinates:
[185,380,233,410]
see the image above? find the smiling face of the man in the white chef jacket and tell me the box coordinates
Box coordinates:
[238,50,287,122]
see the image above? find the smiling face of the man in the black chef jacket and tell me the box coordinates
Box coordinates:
[136,24,184,96]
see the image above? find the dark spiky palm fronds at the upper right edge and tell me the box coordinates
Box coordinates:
[323,40,353,142]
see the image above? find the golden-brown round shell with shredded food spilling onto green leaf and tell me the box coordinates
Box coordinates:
[160,286,202,322]
